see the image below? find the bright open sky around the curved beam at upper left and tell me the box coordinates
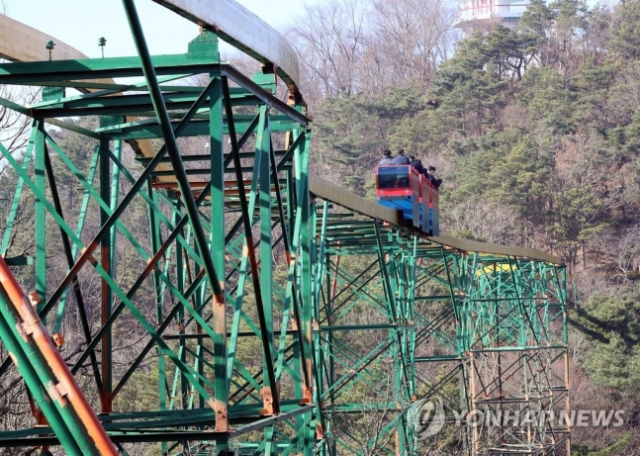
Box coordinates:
[3,0,322,57]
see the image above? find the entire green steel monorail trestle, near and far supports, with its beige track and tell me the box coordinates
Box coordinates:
[0,0,570,456]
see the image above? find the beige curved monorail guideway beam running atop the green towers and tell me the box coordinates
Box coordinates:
[0,0,562,265]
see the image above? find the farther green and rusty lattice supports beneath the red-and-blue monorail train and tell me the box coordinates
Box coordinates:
[314,203,570,455]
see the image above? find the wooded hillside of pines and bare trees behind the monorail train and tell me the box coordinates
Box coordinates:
[290,0,640,455]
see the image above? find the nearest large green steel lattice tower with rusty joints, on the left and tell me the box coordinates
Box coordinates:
[0,9,314,454]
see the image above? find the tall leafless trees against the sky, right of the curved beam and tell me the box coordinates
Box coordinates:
[288,0,455,102]
